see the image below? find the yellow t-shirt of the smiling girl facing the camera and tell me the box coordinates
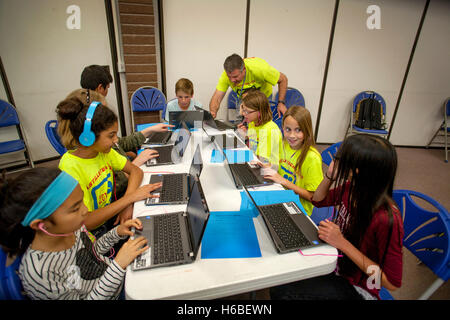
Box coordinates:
[278,141,323,216]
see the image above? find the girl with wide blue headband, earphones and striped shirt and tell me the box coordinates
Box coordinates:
[0,168,150,300]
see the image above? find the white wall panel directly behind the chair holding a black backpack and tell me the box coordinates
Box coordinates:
[317,0,425,142]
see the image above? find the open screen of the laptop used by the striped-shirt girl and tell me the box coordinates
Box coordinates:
[187,181,209,254]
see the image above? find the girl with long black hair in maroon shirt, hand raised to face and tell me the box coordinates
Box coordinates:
[271,134,403,299]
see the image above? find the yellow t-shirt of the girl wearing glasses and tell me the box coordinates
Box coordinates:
[247,120,283,165]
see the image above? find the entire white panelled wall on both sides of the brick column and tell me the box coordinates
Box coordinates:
[0,0,450,160]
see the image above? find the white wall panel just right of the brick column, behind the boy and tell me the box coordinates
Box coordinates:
[163,0,247,118]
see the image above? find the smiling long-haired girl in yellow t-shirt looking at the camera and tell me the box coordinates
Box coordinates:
[265,106,323,216]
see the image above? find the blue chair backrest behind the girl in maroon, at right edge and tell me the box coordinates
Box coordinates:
[393,190,450,281]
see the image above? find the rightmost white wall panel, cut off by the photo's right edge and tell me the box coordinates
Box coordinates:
[390,1,450,146]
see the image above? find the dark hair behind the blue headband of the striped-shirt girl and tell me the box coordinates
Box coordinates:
[0,168,61,256]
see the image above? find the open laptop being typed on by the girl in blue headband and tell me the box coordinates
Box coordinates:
[131,181,209,270]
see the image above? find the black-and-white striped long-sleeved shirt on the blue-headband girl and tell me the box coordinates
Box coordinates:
[19,226,125,300]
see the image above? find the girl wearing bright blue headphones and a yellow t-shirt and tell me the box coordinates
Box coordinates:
[57,97,160,235]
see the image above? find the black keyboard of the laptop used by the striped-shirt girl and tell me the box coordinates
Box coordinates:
[153,214,184,264]
